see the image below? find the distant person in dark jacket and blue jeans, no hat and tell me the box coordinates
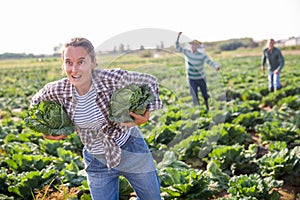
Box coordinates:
[261,39,284,92]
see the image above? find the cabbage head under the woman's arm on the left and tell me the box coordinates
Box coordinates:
[24,101,75,136]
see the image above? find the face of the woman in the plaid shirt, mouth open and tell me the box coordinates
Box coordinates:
[63,46,96,95]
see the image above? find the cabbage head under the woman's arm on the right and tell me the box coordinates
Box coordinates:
[109,84,154,123]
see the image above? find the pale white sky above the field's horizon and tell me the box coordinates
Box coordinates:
[0,0,300,54]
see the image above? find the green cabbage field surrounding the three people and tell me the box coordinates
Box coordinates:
[0,50,300,200]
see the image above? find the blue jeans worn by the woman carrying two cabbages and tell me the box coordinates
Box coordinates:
[83,127,161,200]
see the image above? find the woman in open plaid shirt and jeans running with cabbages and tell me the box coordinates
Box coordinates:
[32,38,162,200]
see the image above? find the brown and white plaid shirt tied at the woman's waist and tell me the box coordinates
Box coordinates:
[31,69,162,168]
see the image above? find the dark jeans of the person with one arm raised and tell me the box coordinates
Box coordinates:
[189,79,209,106]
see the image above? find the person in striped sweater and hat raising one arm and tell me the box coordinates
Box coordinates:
[176,32,220,110]
